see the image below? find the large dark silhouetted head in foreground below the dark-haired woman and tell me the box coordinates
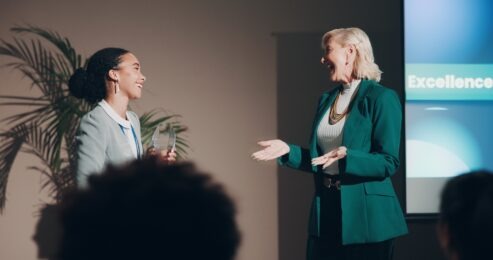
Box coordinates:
[60,158,239,260]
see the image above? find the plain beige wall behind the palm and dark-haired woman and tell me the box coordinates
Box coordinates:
[0,0,326,260]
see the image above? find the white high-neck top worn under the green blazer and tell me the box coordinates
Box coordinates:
[317,79,361,175]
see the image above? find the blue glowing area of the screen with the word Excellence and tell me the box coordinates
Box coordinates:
[404,0,493,181]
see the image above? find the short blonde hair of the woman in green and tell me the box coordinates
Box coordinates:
[322,27,382,82]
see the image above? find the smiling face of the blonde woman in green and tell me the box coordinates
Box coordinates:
[321,38,356,84]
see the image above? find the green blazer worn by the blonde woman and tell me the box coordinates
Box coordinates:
[278,80,407,245]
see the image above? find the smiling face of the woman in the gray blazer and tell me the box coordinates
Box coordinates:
[114,53,146,99]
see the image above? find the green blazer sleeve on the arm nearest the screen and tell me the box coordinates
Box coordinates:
[342,89,402,178]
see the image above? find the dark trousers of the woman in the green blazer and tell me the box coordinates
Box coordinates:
[307,187,394,260]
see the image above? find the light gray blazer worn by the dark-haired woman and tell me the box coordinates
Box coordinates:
[76,105,143,187]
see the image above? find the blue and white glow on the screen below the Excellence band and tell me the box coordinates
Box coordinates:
[406,102,484,177]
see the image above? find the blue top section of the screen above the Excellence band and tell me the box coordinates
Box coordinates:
[404,0,493,64]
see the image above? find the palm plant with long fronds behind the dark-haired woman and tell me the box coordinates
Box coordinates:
[0,26,188,212]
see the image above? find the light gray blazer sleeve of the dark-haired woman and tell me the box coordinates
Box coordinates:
[76,113,107,187]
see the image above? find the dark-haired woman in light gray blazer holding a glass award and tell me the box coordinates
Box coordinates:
[69,48,176,187]
